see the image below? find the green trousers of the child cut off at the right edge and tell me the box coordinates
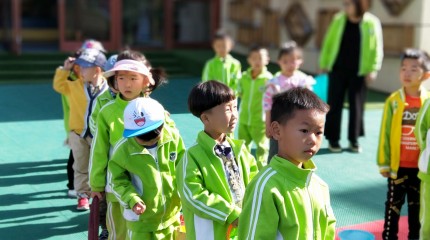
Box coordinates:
[420,180,430,240]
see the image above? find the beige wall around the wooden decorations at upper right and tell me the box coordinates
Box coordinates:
[221,0,430,92]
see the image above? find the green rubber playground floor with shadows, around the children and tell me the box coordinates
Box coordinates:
[0,78,404,240]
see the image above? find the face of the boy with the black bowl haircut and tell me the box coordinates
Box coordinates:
[201,99,237,136]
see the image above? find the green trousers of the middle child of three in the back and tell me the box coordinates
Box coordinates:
[238,123,269,169]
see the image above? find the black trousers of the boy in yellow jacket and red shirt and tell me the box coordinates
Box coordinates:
[382,168,420,240]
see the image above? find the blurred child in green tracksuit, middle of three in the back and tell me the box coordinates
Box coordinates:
[238,47,273,169]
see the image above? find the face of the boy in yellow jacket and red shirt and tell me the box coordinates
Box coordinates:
[400,58,426,88]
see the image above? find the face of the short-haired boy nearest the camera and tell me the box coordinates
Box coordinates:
[271,110,325,166]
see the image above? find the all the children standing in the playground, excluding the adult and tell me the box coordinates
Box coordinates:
[54,34,430,239]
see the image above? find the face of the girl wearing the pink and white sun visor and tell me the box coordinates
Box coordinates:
[115,71,150,101]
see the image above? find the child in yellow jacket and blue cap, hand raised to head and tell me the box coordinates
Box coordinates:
[53,45,107,210]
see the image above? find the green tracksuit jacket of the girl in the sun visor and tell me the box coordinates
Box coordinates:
[89,94,128,201]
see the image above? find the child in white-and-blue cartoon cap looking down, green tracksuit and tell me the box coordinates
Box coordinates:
[108,97,185,240]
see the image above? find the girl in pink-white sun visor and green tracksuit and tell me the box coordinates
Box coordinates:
[89,51,165,239]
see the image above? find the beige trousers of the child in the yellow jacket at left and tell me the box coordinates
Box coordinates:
[69,131,91,197]
